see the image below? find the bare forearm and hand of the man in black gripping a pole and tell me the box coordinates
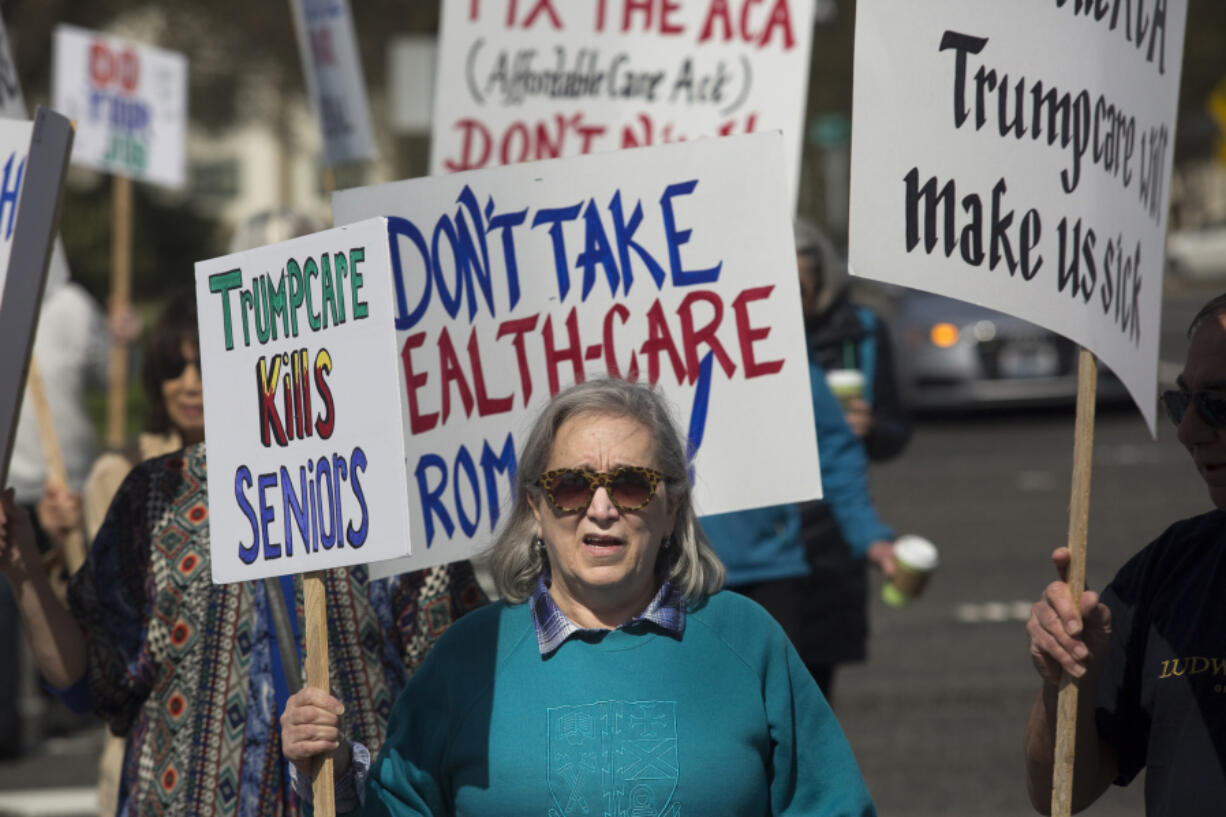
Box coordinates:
[1025,547,1116,815]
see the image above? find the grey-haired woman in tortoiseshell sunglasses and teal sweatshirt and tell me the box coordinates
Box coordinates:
[282,379,874,817]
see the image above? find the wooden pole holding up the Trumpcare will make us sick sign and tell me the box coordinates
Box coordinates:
[1052,347,1098,817]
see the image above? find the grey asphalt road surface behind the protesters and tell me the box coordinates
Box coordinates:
[0,283,1208,817]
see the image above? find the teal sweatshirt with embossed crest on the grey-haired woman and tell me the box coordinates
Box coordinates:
[364,593,875,817]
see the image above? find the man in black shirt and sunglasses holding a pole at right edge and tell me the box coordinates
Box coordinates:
[1026,294,1226,817]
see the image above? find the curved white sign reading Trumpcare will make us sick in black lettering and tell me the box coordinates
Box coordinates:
[850,0,1187,432]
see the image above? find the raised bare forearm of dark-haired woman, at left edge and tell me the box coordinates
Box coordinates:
[0,488,86,689]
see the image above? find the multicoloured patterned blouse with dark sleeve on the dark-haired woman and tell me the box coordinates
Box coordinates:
[69,444,485,817]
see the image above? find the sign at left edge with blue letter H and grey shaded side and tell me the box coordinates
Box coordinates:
[0,108,72,486]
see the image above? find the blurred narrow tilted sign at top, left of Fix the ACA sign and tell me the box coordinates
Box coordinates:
[289,0,375,167]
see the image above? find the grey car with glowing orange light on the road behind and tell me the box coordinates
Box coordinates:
[890,290,1128,413]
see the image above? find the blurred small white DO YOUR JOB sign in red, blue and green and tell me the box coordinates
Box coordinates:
[51,23,188,188]
